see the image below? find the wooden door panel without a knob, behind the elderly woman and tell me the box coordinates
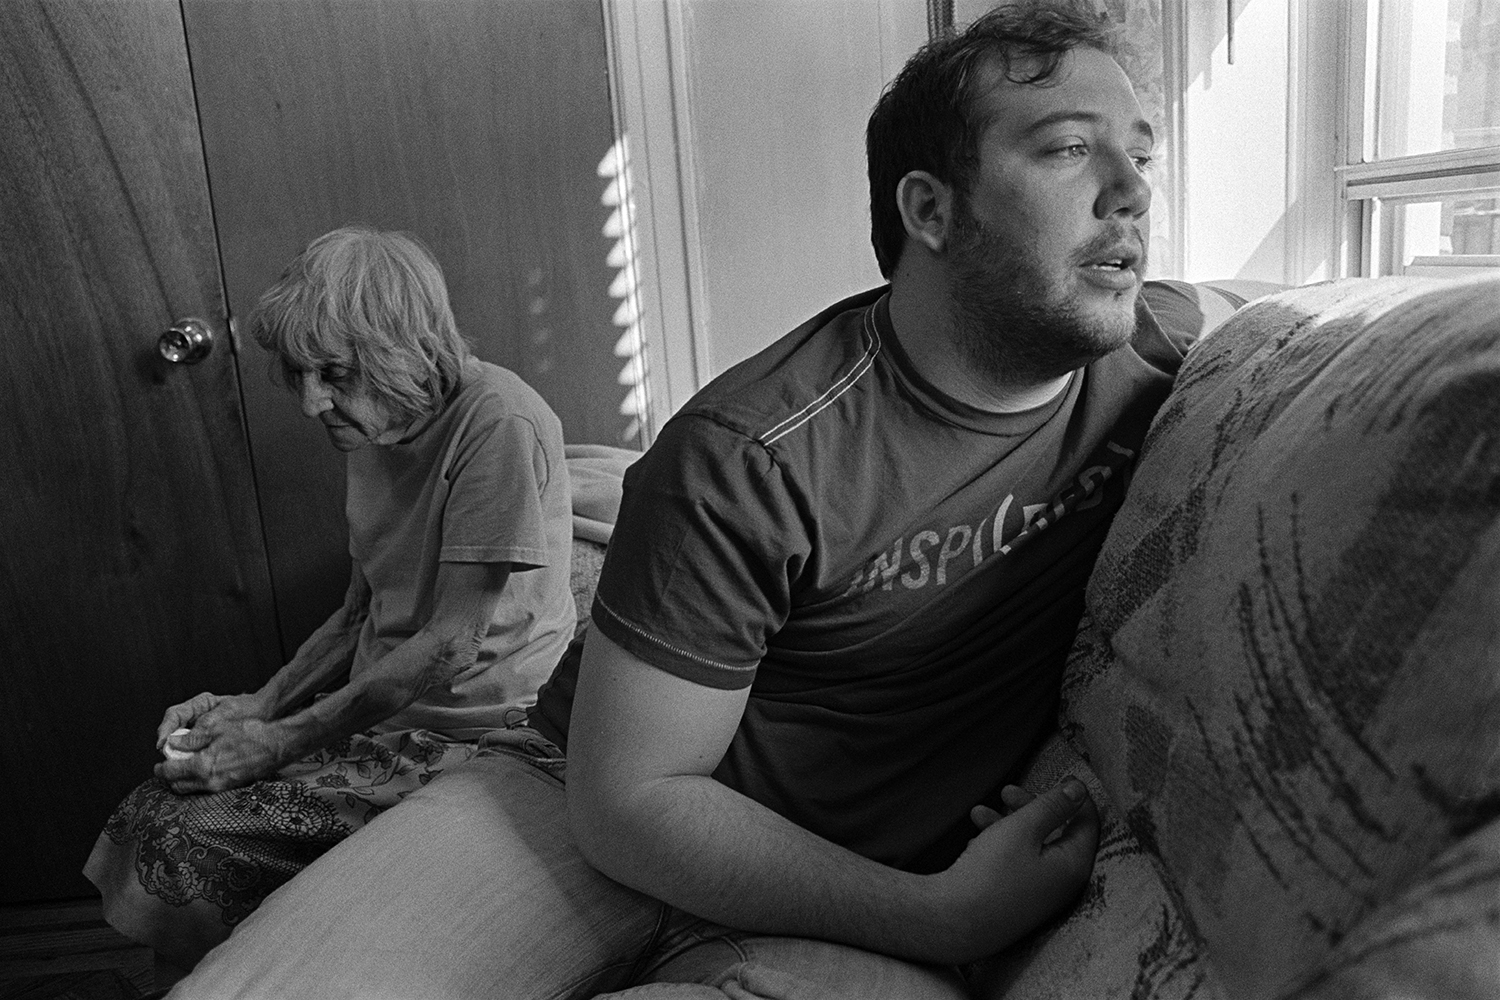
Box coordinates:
[183,0,629,652]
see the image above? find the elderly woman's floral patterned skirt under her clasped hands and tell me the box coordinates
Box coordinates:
[84,729,480,966]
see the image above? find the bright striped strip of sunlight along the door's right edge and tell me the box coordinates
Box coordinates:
[599,135,650,444]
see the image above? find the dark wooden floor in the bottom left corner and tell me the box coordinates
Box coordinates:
[0,898,183,1000]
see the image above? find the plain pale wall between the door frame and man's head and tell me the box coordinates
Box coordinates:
[684,0,927,373]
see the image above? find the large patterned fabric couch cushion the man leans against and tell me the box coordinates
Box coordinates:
[1064,277,1500,997]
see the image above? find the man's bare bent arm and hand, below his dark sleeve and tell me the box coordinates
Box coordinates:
[567,630,1098,963]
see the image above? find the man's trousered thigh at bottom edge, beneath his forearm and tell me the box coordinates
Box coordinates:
[597,918,969,1000]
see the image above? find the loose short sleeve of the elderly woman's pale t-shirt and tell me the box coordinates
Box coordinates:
[438,414,554,570]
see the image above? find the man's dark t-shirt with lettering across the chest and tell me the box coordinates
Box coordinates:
[533,289,1181,870]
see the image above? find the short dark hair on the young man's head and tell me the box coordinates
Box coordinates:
[864,0,1116,279]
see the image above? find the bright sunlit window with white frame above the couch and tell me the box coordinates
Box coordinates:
[1337,0,1500,274]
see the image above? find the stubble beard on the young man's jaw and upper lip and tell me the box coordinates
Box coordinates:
[948,208,1146,385]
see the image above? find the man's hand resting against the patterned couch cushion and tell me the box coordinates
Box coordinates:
[933,778,1100,963]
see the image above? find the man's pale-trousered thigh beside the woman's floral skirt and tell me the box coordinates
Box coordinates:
[171,756,662,1000]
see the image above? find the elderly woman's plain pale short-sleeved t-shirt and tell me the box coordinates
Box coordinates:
[345,358,578,736]
